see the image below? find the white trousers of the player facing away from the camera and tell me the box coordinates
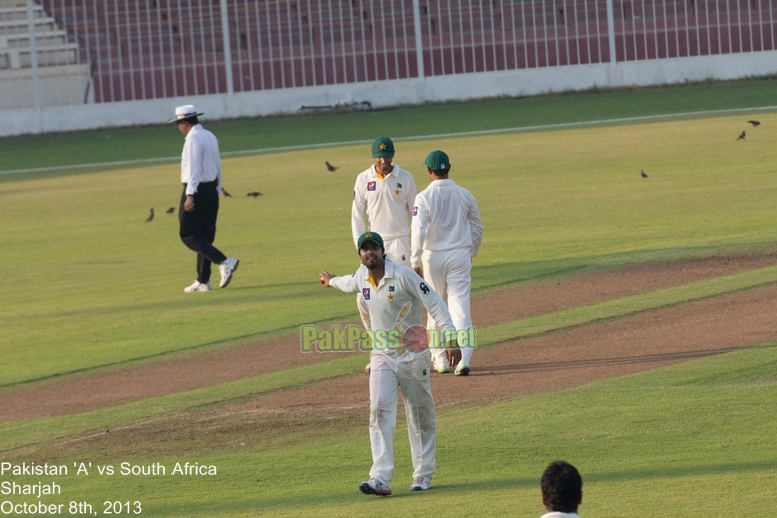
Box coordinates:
[421,248,475,369]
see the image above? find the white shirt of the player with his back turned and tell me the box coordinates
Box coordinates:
[410,179,483,268]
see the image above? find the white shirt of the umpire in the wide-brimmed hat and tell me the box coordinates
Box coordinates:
[181,124,221,195]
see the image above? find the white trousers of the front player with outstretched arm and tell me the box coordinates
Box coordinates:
[370,351,437,485]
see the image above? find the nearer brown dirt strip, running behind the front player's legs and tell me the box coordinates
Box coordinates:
[225,286,777,412]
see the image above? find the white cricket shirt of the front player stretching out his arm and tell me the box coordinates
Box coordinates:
[329,261,456,353]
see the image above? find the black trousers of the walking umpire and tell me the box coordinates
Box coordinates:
[178,182,227,284]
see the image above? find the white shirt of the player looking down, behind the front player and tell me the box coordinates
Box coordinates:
[351,164,417,249]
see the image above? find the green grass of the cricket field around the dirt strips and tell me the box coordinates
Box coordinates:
[0,78,777,517]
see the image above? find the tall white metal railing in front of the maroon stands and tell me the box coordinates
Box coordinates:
[0,0,777,109]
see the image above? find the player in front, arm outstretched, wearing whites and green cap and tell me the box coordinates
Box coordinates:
[320,232,458,496]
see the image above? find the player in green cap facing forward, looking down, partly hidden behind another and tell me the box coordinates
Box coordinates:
[351,137,418,329]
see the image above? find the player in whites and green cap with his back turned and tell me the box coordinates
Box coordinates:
[410,150,483,376]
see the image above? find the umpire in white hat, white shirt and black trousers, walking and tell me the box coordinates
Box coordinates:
[169,104,240,293]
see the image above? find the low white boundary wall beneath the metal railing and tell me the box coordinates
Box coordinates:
[0,51,777,136]
